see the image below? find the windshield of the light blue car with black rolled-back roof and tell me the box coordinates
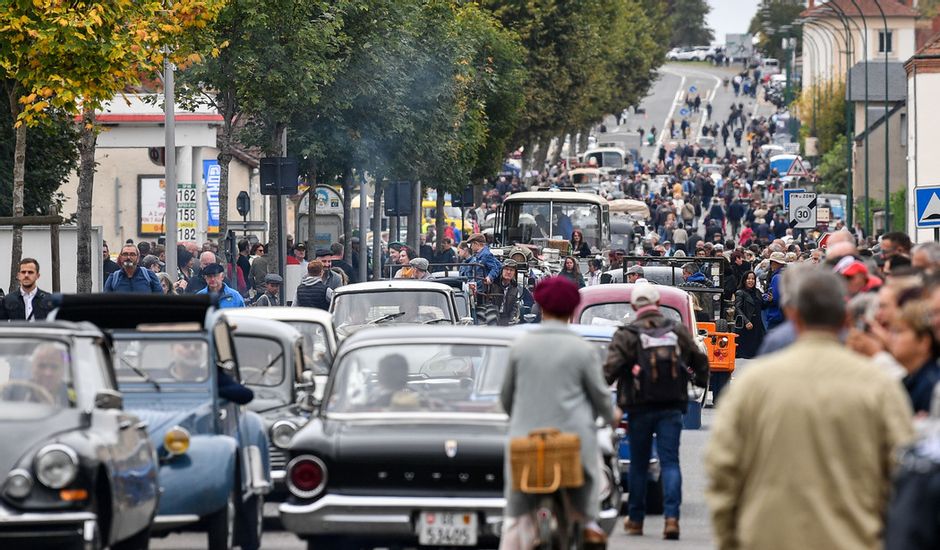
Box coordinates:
[114,338,209,384]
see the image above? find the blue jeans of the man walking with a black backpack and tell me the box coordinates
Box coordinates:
[627,410,682,522]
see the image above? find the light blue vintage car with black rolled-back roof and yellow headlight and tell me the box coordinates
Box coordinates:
[53,294,271,550]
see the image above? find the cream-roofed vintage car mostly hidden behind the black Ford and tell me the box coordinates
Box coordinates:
[330,279,473,338]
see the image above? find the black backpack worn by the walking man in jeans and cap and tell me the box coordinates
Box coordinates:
[624,321,689,405]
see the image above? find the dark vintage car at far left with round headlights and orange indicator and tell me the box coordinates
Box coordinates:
[0,322,159,549]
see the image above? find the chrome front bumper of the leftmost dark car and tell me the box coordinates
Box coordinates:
[0,505,98,546]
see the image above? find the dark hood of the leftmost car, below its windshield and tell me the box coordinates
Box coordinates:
[0,403,83,477]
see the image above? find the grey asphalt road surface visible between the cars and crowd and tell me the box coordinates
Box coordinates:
[151,63,773,550]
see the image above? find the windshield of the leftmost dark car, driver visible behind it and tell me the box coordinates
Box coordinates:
[0,338,75,416]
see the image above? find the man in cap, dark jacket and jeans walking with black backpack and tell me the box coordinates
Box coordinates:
[604,284,708,540]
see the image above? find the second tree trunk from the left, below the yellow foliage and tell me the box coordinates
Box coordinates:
[76,109,96,292]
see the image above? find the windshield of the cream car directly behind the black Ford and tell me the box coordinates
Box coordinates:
[333,289,454,332]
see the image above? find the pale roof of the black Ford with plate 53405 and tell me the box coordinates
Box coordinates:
[342,325,518,348]
